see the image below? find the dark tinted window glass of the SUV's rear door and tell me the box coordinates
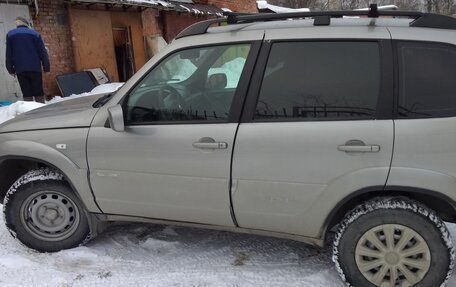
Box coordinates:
[254,42,380,121]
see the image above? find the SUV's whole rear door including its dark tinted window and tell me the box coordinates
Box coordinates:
[232,31,393,238]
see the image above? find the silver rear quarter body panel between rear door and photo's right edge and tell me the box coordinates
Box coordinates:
[387,117,456,201]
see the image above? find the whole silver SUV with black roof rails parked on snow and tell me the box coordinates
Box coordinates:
[0,6,456,287]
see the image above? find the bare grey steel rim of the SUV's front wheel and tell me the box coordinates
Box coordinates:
[20,191,80,241]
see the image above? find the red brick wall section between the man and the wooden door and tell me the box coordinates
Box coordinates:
[30,0,74,96]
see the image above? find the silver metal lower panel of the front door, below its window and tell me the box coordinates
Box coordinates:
[87,124,237,226]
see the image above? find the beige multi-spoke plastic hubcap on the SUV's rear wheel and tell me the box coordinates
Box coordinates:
[355,224,431,287]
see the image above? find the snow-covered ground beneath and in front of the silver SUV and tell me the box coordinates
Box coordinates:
[0,205,456,287]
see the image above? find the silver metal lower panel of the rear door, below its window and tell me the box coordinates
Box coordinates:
[233,120,393,237]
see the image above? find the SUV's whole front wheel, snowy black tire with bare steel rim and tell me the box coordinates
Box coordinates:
[3,168,90,252]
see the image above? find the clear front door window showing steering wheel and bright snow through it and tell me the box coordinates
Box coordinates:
[124,44,250,125]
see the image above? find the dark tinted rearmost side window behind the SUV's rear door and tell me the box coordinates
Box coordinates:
[398,42,456,118]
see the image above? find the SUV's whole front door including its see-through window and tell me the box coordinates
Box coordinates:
[87,43,259,226]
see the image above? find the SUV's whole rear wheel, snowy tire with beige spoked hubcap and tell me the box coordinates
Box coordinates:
[333,197,454,287]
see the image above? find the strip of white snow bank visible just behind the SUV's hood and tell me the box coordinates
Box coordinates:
[0,83,124,124]
